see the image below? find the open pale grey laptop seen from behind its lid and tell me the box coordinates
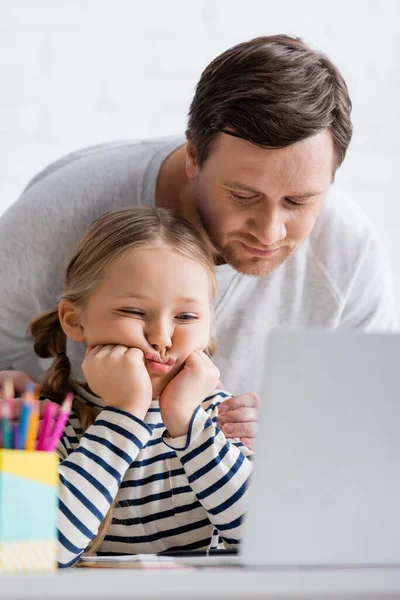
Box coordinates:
[238,331,400,566]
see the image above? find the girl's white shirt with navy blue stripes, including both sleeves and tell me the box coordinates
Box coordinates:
[57,384,251,567]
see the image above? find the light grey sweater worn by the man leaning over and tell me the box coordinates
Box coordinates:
[0,137,397,396]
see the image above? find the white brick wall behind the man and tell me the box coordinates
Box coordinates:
[0,0,400,298]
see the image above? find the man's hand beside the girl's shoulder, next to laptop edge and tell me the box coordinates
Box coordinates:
[218,392,260,450]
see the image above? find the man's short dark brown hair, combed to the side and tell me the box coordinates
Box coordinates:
[186,35,352,170]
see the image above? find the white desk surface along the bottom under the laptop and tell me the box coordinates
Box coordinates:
[0,568,400,600]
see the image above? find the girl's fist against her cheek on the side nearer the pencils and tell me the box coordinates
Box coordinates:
[82,344,152,419]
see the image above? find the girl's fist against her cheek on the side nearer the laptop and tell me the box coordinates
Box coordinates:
[160,350,219,437]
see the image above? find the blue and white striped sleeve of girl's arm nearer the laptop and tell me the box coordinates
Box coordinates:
[163,392,252,547]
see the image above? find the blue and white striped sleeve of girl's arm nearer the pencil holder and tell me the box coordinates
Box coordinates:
[57,407,152,567]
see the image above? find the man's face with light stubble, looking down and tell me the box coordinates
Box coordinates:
[186,131,334,276]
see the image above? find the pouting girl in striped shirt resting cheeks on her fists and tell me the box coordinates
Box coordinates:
[28,207,251,567]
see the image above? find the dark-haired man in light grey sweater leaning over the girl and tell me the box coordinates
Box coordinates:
[0,35,395,446]
